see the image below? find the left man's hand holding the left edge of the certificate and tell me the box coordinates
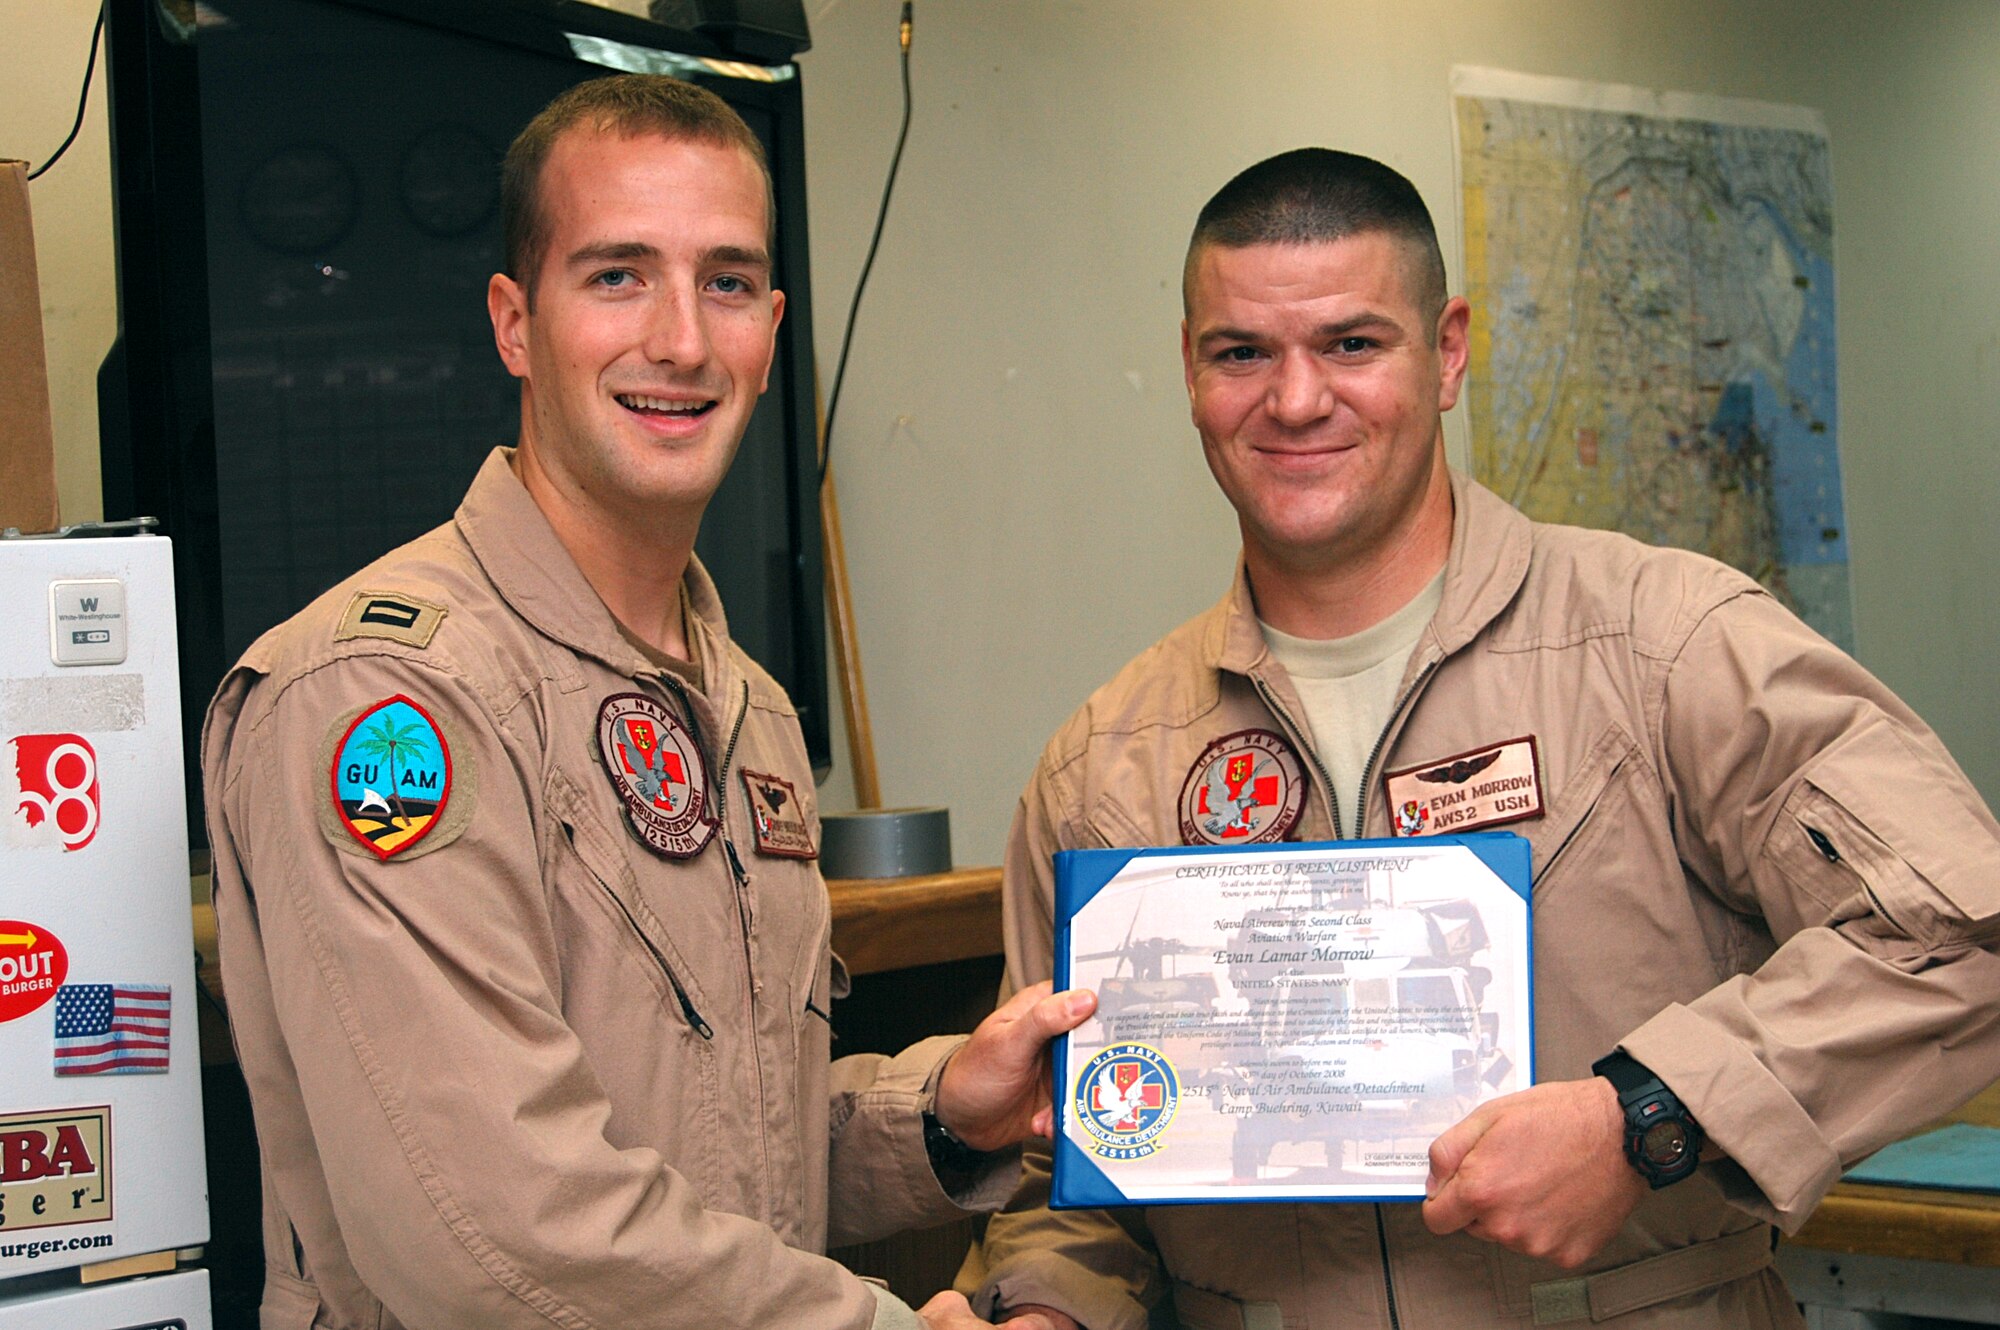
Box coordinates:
[932,982,1098,1150]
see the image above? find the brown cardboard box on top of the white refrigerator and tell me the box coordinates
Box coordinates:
[0,162,58,532]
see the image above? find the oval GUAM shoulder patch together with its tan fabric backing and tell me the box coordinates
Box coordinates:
[320,692,474,860]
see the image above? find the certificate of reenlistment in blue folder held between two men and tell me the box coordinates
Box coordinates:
[1050,832,1534,1208]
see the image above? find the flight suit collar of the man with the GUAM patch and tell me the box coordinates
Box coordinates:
[454,448,730,694]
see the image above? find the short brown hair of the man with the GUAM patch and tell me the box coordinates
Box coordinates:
[500,74,778,308]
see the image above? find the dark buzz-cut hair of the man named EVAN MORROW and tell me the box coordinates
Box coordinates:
[1182,148,1446,336]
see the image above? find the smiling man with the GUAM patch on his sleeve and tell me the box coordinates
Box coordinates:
[204,76,1092,1330]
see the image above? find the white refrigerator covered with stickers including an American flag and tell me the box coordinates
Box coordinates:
[0,534,210,1330]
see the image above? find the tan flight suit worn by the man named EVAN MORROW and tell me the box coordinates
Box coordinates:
[960,478,2000,1330]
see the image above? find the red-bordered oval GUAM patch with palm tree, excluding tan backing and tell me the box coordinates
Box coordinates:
[328,692,452,860]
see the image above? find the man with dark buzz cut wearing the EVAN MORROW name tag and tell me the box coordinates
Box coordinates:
[960,148,2000,1330]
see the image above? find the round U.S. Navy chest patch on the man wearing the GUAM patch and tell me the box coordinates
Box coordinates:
[598,692,716,858]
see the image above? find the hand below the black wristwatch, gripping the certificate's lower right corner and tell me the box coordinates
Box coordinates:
[1424,1076,1646,1270]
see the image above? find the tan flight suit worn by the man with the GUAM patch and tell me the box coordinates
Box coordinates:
[204,450,1018,1330]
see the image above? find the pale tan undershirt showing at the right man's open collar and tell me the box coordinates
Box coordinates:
[1258,570,1444,836]
